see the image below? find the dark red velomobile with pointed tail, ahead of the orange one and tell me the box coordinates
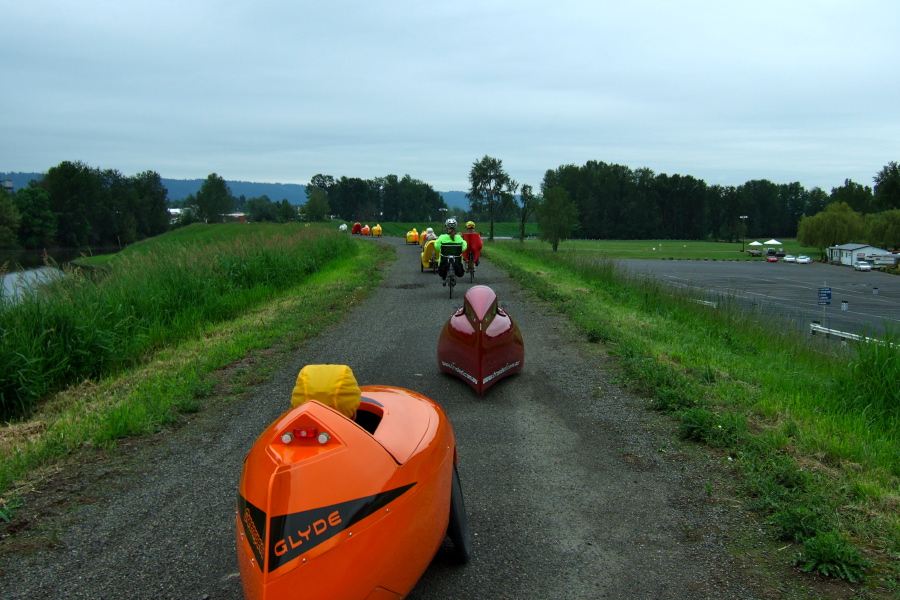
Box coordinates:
[438,285,525,396]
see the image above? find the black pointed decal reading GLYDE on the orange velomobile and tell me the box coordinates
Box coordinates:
[268,483,416,573]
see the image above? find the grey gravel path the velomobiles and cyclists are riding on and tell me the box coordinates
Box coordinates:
[0,238,778,600]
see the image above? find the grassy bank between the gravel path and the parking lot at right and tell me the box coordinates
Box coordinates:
[485,242,900,593]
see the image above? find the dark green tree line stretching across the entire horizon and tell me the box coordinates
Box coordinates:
[0,156,900,248]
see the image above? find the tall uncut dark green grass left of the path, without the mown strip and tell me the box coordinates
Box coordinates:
[0,227,354,419]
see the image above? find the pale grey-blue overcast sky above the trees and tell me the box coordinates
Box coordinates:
[0,0,900,191]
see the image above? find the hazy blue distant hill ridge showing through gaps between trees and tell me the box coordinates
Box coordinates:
[0,173,469,209]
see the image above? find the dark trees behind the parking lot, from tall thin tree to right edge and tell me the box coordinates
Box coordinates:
[467,156,900,249]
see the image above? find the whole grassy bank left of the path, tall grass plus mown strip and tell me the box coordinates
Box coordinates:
[0,224,392,508]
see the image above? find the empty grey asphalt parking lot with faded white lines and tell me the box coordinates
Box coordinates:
[617,259,900,337]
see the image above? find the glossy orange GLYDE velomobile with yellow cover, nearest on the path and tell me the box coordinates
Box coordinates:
[236,365,470,600]
